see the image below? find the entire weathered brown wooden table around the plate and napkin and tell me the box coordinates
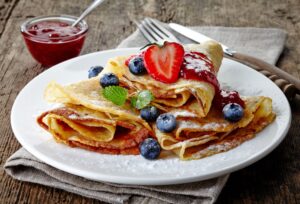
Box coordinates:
[0,0,300,203]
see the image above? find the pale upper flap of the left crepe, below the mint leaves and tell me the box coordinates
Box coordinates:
[44,78,152,131]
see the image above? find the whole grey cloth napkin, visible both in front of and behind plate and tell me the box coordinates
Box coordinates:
[4,27,286,204]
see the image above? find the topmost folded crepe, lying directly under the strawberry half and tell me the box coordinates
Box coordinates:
[100,41,223,117]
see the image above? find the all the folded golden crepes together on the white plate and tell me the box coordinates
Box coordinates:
[38,42,275,160]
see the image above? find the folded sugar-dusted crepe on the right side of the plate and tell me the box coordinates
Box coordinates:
[153,96,275,160]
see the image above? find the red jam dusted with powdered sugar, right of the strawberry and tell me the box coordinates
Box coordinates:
[180,52,245,110]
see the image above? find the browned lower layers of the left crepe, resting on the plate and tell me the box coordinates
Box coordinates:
[37,105,149,154]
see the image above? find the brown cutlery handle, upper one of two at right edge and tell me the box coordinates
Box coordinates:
[228,53,300,97]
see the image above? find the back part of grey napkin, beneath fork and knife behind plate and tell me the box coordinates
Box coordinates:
[118,27,286,64]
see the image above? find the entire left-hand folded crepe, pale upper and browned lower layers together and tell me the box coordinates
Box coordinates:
[37,78,153,154]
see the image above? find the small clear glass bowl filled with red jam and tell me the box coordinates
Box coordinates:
[22,20,87,67]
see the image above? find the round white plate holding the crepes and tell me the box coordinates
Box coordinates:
[11,48,291,185]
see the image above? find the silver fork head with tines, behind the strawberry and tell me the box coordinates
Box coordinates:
[135,18,179,44]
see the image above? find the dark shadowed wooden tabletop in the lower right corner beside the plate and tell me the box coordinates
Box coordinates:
[218,111,300,204]
